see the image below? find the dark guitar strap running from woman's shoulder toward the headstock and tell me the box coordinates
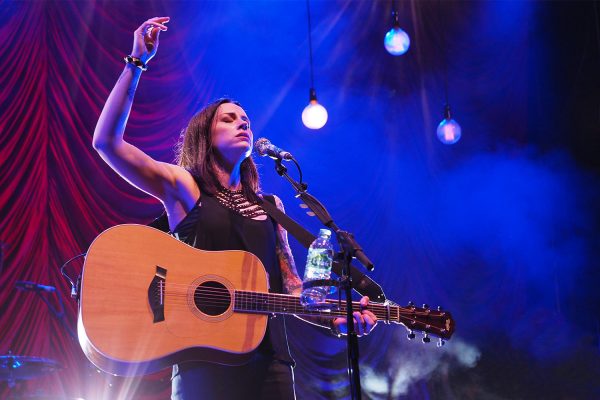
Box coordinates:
[259,195,386,303]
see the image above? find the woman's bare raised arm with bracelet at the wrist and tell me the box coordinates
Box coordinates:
[92,17,190,203]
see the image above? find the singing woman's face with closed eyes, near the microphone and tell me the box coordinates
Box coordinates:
[212,103,254,163]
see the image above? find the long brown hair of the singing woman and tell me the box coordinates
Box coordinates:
[176,98,260,200]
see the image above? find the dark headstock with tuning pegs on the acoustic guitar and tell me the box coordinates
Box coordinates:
[393,302,454,346]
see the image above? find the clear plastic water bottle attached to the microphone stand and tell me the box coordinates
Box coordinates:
[300,229,333,307]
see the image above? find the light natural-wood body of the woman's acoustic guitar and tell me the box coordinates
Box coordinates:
[78,225,268,375]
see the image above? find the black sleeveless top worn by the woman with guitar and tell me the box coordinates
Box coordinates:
[171,184,294,364]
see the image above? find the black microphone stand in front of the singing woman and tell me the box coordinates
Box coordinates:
[275,158,375,400]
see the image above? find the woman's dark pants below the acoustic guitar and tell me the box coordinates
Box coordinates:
[171,353,296,400]
